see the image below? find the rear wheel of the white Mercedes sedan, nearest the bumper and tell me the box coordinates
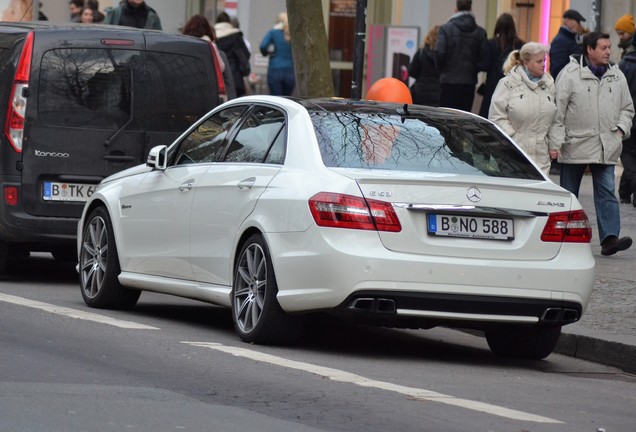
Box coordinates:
[232,234,301,344]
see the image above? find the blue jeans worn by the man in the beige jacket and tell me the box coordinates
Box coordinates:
[561,163,621,244]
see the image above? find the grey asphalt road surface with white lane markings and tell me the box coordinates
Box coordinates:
[0,257,636,432]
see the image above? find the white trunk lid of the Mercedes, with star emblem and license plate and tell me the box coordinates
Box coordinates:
[340,172,572,260]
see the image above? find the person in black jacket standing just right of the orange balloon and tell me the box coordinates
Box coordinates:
[409,26,442,106]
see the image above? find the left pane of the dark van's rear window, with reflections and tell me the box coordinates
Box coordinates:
[38,49,142,129]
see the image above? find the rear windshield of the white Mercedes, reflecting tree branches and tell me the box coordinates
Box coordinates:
[310,110,543,179]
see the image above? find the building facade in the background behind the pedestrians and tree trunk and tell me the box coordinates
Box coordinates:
[27,0,636,96]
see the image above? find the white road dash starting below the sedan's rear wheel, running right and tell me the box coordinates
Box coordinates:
[181,341,563,424]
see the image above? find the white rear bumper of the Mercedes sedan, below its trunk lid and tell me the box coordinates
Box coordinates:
[267,228,594,323]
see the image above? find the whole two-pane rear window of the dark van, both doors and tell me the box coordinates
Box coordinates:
[38,48,218,132]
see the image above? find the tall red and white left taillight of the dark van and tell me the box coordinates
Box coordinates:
[4,32,33,152]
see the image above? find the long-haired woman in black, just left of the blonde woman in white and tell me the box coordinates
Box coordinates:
[477,13,523,118]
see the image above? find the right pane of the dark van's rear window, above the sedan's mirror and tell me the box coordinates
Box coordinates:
[145,51,218,132]
